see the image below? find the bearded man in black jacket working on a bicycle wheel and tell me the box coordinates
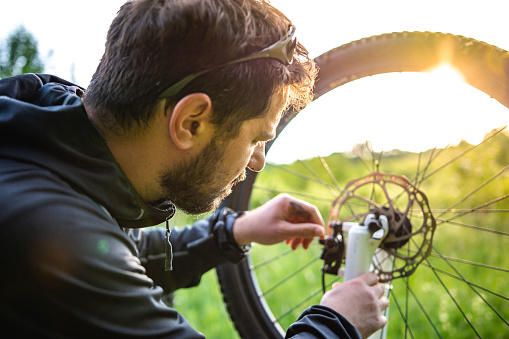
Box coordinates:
[0,0,388,338]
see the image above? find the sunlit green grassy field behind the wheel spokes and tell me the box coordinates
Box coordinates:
[170,134,509,338]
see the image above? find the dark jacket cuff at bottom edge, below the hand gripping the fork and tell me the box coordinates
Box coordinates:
[285,305,362,339]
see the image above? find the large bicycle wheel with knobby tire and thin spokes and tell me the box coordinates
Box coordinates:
[217,32,509,338]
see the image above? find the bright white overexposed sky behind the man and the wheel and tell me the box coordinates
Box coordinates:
[0,0,509,161]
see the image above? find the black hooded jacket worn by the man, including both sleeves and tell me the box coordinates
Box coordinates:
[0,74,357,338]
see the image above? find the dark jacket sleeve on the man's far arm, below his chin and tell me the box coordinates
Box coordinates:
[130,208,245,293]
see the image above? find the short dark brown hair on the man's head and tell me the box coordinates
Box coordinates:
[84,0,316,137]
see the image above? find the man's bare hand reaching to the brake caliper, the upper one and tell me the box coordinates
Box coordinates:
[233,194,325,249]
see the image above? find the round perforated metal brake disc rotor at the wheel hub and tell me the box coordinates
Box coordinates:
[328,172,436,282]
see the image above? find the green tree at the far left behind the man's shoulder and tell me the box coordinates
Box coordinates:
[0,26,44,79]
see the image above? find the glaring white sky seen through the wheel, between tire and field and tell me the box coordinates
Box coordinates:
[267,68,509,163]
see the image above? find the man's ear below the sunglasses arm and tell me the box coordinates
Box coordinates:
[168,93,213,149]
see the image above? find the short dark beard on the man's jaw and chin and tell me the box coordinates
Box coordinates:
[160,136,246,214]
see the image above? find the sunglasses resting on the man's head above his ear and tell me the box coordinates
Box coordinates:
[159,26,297,99]
